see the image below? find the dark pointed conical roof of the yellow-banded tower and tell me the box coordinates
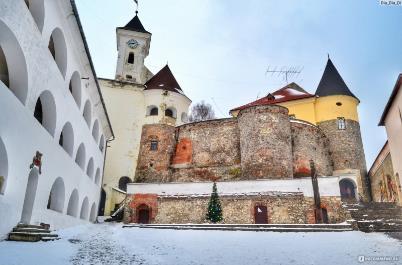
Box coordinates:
[315,58,359,100]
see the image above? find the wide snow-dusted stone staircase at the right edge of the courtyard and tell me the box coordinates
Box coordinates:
[343,202,402,232]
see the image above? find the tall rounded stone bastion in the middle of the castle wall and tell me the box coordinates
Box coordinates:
[238,105,293,179]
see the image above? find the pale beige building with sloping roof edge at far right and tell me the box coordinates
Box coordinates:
[379,74,402,204]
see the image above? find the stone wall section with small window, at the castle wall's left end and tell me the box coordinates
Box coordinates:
[135,124,176,182]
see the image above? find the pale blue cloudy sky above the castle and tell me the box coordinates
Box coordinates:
[76,0,402,169]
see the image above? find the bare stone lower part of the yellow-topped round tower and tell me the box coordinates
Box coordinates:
[318,120,370,200]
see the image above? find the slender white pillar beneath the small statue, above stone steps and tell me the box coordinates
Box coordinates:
[21,168,39,224]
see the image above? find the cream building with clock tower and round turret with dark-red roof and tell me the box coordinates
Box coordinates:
[99,11,191,215]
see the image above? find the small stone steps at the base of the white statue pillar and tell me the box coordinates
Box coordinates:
[8,224,59,242]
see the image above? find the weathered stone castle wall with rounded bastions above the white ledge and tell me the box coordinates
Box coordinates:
[135,105,367,183]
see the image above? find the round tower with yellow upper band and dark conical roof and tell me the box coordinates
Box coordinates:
[315,58,369,199]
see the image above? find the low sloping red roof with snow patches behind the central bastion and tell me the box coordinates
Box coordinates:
[231,83,315,111]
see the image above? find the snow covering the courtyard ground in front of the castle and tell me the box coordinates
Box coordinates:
[0,224,402,265]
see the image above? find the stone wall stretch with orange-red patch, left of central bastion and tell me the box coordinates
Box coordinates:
[171,119,241,181]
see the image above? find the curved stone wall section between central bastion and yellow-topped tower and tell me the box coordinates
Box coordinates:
[290,121,333,177]
